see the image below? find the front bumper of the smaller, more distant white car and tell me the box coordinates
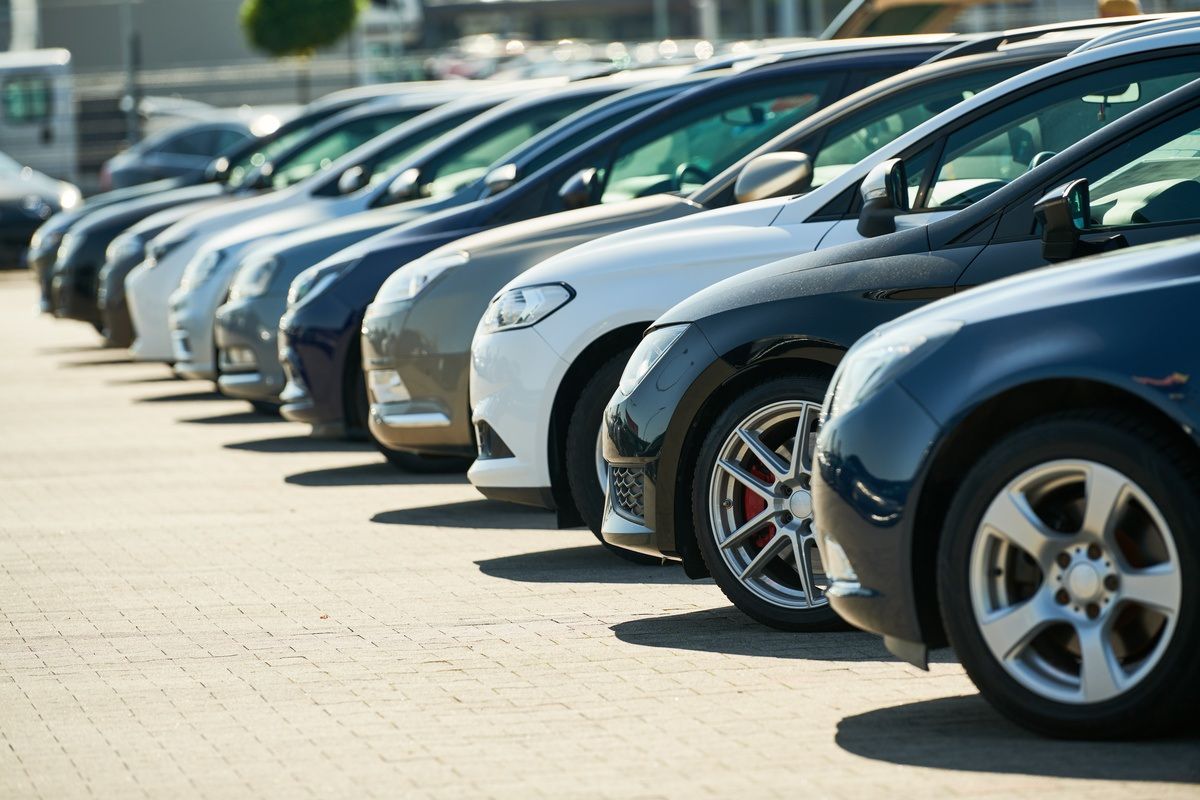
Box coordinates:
[125,237,203,362]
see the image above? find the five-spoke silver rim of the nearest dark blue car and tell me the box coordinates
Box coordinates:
[970,461,1182,704]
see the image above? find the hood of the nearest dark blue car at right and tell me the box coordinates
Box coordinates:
[880,236,1200,330]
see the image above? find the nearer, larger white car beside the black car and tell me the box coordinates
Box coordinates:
[468,17,1200,535]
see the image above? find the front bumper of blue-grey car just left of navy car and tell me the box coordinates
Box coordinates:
[212,294,287,403]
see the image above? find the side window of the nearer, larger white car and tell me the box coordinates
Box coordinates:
[923,54,1200,209]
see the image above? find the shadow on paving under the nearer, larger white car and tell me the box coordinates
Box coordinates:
[475,545,690,584]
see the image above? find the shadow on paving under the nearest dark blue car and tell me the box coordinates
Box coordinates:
[836,694,1200,783]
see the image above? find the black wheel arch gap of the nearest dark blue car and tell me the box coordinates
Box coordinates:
[910,377,1200,646]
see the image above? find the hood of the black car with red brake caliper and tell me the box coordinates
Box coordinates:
[654,225,929,325]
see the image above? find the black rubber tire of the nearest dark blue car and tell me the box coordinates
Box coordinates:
[937,410,1200,739]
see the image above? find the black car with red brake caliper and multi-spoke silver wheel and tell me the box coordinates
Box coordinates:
[604,71,1200,630]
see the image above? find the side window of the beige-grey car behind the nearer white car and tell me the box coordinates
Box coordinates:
[810,64,1028,188]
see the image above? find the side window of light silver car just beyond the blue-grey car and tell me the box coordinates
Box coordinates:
[421,95,609,198]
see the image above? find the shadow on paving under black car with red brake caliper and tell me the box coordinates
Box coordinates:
[612,606,895,661]
